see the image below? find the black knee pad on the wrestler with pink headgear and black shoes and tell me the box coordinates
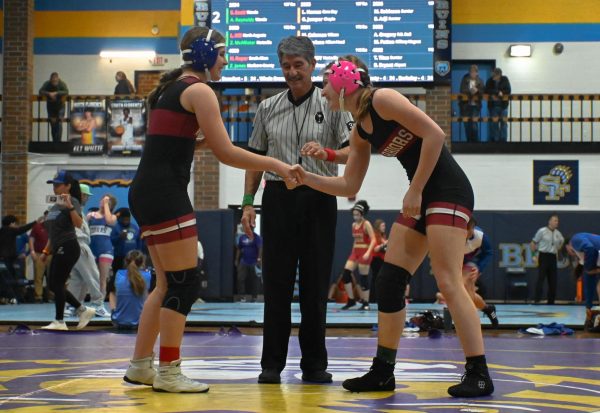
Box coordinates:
[375,262,411,313]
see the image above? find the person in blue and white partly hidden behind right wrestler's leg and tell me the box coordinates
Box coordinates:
[436,217,499,327]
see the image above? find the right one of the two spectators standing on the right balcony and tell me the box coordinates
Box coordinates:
[485,67,510,142]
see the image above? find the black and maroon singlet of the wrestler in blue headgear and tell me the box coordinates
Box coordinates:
[129,76,199,245]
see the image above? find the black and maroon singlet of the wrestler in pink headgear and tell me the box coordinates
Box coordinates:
[357,91,474,234]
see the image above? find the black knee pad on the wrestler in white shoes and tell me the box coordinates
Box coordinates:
[162,267,200,316]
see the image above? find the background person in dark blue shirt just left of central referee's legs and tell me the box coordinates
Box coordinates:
[235,231,262,299]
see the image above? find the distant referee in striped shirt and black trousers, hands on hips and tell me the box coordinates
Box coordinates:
[530,214,565,304]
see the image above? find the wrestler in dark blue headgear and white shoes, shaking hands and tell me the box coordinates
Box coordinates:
[124,27,298,393]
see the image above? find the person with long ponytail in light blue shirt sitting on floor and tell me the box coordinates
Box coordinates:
[108,250,151,329]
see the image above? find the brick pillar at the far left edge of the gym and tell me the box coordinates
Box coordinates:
[2,0,34,223]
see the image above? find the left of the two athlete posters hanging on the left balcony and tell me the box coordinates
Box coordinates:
[69,99,106,155]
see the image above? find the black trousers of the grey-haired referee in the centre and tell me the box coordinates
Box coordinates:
[261,181,337,372]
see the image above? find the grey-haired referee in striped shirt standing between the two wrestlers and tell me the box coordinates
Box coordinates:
[242,36,353,383]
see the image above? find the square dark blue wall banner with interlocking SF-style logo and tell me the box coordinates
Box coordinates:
[533,160,579,205]
